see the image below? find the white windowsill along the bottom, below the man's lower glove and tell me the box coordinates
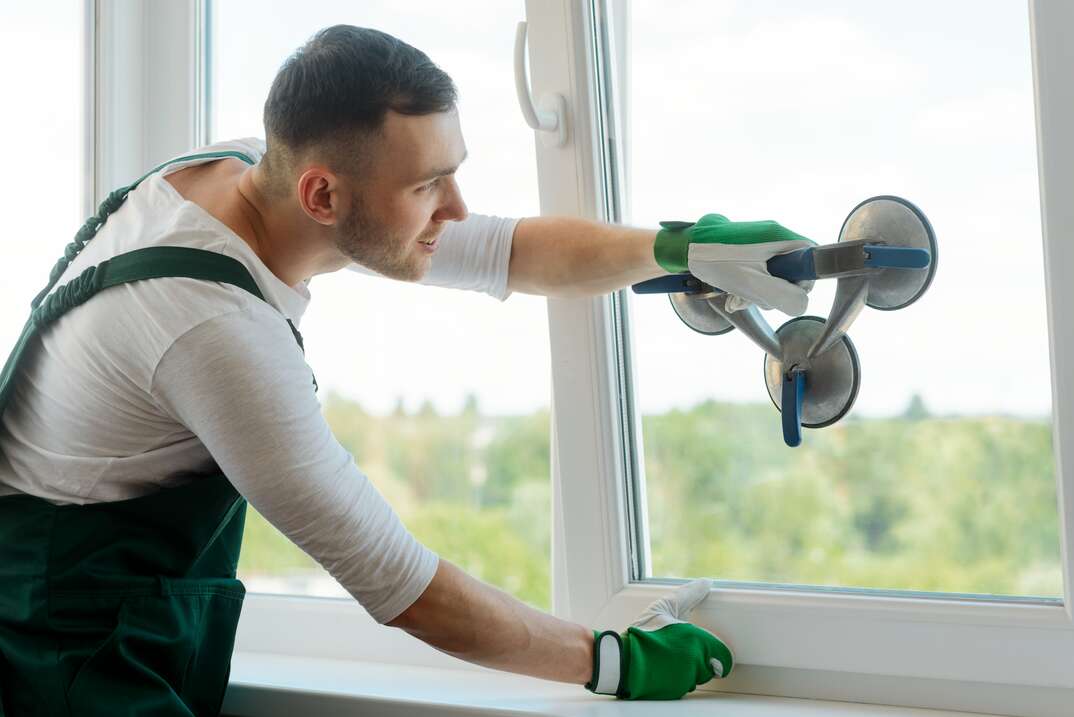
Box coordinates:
[222,653,996,717]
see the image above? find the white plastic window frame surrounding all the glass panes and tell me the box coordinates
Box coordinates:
[94,0,1074,715]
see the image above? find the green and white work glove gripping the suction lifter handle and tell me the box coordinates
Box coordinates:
[653,214,816,317]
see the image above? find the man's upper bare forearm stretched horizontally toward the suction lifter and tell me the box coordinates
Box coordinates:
[507,217,667,297]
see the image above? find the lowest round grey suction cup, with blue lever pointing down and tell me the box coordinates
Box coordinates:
[765,317,861,428]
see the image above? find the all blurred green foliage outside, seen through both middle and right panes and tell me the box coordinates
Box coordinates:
[241,394,1062,609]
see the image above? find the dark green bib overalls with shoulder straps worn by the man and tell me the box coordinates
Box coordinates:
[0,151,316,717]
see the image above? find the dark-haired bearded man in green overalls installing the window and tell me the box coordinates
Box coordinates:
[0,26,811,715]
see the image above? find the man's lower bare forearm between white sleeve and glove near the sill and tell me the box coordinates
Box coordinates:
[388,558,593,685]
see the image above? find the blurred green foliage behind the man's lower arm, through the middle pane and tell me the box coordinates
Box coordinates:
[240,394,551,610]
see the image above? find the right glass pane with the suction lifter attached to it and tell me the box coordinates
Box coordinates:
[626,0,1062,598]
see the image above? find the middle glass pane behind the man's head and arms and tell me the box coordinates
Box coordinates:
[212,0,551,608]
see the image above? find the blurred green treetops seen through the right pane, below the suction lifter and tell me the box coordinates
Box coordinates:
[644,403,1062,597]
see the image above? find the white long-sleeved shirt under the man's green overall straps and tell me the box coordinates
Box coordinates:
[0,140,517,623]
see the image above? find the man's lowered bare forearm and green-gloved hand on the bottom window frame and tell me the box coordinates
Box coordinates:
[388,559,735,700]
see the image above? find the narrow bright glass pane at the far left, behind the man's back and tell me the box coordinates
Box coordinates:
[0,0,86,360]
